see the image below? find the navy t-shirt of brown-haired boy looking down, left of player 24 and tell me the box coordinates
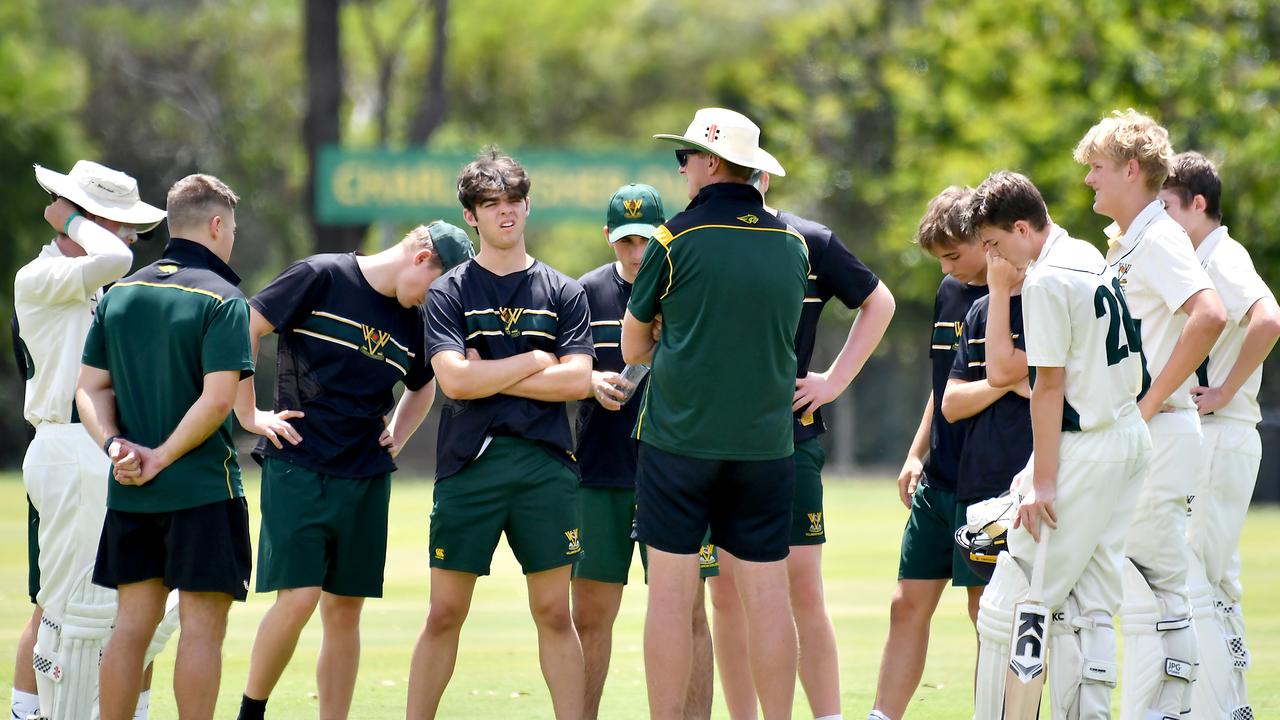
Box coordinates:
[924,275,987,492]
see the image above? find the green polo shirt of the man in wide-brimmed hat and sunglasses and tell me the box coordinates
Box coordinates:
[627,183,809,460]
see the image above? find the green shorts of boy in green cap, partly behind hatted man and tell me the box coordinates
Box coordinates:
[573,487,719,584]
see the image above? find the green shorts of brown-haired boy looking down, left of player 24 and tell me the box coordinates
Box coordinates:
[897,480,987,587]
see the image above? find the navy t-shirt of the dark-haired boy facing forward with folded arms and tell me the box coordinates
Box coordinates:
[426,260,595,480]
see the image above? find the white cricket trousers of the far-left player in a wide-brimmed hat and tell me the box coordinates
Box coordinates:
[22,423,110,620]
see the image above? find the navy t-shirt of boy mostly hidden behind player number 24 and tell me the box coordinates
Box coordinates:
[951,295,1032,501]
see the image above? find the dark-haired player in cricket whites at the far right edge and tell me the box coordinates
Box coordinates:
[1160,152,1280,717]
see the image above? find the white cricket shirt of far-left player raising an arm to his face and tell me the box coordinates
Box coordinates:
[13,217,133,427]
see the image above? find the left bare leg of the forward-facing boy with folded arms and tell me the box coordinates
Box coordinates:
[406,568,476,720]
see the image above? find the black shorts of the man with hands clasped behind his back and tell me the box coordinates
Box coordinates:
[93,497,253,600]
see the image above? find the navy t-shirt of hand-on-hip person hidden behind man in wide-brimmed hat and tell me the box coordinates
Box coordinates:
[778,210,879,442]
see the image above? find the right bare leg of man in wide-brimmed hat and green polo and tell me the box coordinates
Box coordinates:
[737,550,797,720]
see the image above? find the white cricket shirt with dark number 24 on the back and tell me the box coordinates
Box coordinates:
[1023,225,1142,432]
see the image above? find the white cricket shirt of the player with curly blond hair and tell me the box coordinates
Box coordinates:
[1107,200,1213,410]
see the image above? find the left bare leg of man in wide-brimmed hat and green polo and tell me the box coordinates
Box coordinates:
[644,547,700,720]
